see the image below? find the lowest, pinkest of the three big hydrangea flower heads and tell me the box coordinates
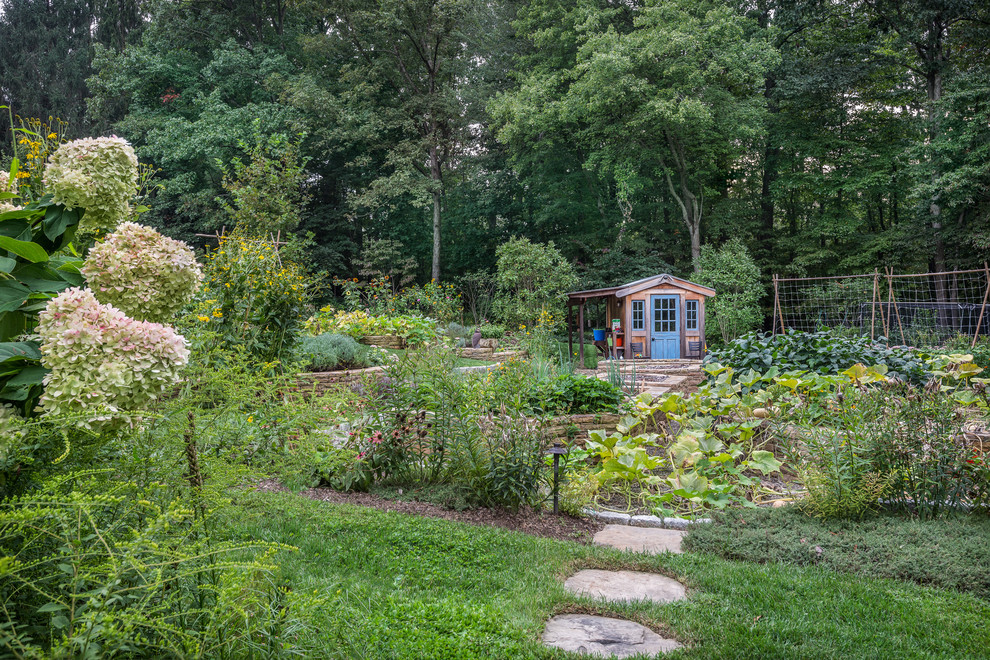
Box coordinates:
[38,288,189,429]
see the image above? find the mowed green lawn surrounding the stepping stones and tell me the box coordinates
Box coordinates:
[227,493,990,659]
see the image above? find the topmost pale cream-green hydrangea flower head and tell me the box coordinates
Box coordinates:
[45,137,138,235]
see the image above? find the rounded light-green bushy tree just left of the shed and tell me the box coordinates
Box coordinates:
[495,237,578,327]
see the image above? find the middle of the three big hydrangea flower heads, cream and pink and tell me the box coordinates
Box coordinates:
[82,222,203,323]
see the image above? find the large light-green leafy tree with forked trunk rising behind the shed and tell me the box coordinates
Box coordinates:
[503,0,775,268]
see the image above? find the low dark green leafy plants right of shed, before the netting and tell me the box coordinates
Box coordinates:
[705,331,928,383]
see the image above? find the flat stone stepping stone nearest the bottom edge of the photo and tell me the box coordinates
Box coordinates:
[543,614,681,658]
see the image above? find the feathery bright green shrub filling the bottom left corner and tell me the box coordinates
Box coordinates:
[0,473,310,658]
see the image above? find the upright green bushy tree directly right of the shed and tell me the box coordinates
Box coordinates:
[696,238,763,343]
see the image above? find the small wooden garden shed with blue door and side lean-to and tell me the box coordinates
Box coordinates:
[567,273,715,363]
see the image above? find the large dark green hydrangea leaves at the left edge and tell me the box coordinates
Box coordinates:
[0,159,83,415]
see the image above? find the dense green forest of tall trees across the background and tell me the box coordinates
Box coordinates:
[0,0,990,304]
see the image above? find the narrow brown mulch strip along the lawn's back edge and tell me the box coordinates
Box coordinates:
[252,479,605,544]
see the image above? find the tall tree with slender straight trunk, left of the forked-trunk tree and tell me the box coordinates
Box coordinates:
[296,0,490,280]
